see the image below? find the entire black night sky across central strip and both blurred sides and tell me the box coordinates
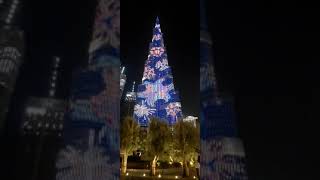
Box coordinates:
[6,0,320,180]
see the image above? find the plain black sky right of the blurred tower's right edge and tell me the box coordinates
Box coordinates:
[207,1,320,180]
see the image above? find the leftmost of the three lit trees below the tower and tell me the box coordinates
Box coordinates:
[120,116,140,173]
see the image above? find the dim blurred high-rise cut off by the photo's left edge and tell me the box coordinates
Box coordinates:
[0,0,24,134]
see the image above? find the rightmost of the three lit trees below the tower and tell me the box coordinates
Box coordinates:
[171,120,200,177]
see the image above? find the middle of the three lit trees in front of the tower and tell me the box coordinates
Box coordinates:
[145,118,171,176]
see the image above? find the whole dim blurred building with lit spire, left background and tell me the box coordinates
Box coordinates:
[19,57,67,180]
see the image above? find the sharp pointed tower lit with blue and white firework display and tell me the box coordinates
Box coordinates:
[134,18,182,126]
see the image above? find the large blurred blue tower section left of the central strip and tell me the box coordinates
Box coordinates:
[56,0,121,180]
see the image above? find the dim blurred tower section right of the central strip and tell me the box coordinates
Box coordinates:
[200,0,248,180]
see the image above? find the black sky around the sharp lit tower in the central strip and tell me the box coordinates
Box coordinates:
[121,0,199,116]
